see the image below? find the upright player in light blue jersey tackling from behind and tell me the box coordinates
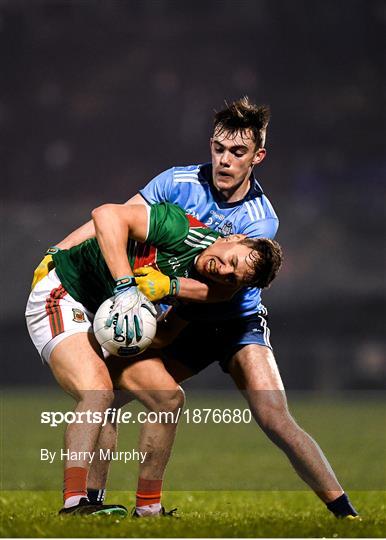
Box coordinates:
[38,98,357,518]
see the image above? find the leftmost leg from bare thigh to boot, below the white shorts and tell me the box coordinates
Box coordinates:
[49,333,127,517]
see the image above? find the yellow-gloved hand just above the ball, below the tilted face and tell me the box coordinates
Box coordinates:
[134,266,180,302]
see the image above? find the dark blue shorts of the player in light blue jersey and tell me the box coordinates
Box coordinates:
[163,310,272,373]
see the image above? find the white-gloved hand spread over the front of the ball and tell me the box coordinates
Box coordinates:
[106,276,157,341]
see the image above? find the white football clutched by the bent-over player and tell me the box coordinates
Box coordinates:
[93,296,157,357]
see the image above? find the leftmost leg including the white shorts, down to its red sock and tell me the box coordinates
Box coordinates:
[26,270,128,513]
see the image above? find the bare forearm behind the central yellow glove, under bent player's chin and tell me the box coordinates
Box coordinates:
[178,278,238,302]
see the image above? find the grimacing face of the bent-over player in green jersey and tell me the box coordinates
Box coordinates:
[196,234,252,287]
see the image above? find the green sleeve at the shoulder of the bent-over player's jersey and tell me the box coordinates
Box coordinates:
[146,202,189,251]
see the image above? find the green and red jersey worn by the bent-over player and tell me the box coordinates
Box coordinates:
[53,203,220,313]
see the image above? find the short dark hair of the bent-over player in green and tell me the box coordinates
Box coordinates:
[240,238,283,289]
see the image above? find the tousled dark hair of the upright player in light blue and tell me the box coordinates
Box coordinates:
[214,96,271,148]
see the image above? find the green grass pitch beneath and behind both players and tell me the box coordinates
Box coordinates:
[0,390,386,538]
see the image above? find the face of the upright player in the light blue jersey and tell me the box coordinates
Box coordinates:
[210,129,266,200]
